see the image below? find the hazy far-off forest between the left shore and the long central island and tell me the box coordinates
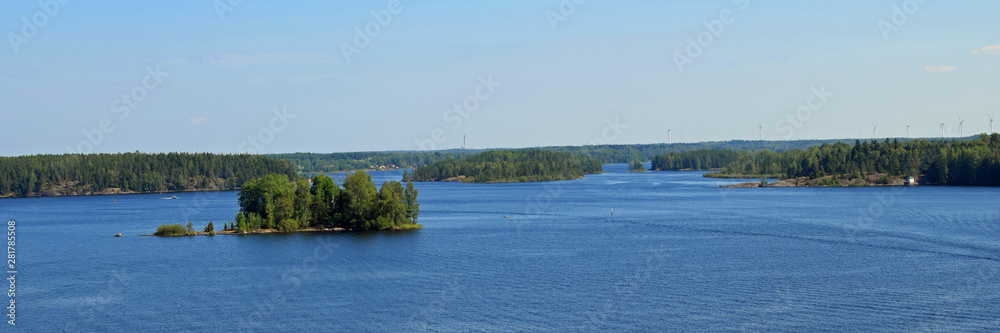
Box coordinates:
[268,150,477,172]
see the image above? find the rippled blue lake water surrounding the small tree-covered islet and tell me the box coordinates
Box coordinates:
[0,165,1000,332]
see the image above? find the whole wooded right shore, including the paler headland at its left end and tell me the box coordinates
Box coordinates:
[653,134,1000,187]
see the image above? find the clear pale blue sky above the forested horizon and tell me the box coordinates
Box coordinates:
[0,0,1000,156]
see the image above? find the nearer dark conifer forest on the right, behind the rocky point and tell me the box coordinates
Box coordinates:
[700,134,1000,186]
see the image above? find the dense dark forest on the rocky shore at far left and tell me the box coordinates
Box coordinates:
[0,152,296,197]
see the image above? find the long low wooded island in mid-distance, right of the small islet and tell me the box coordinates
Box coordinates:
[404,149,601,183]
